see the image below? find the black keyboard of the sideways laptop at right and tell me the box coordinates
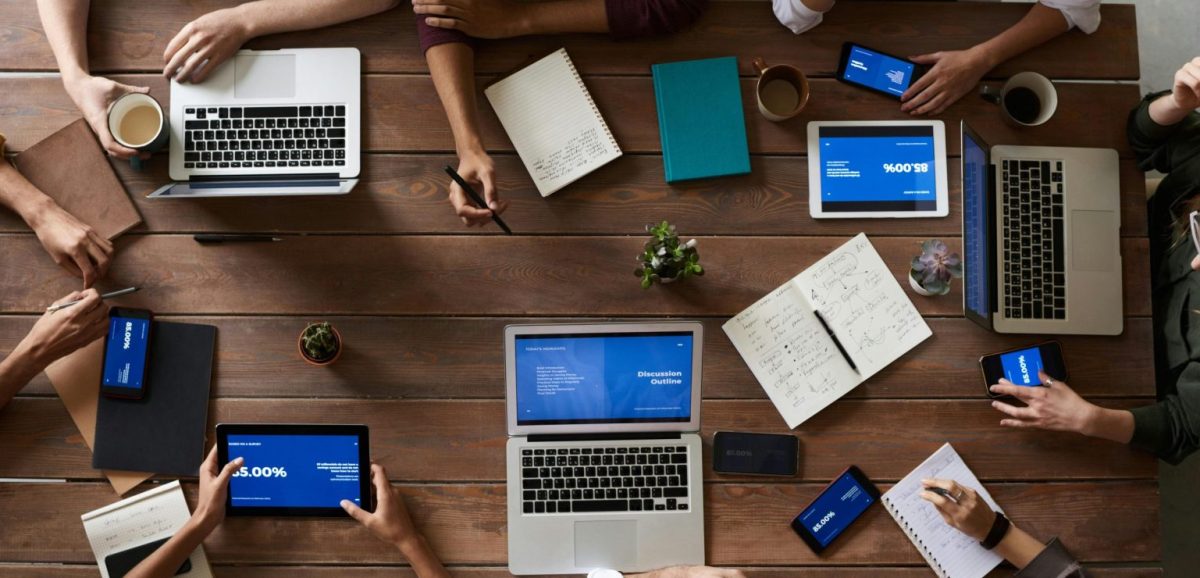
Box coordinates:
[1001,161,1067,319]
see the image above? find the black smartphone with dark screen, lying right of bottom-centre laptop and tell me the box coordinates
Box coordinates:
[713,432,800,476]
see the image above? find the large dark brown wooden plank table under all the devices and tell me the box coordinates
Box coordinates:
[0,0,1160,578]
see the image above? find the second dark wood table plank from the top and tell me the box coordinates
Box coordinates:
[0,74,1140,155]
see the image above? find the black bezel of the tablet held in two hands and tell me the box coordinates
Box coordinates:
[216,423,374,518]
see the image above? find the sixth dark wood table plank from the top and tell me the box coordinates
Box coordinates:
[0,398,1157,482]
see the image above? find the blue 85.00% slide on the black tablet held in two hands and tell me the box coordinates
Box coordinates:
[228,435,362,507]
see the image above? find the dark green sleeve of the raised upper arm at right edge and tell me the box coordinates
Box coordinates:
[1126,90,1200,173]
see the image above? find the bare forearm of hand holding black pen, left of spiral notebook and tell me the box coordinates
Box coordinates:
[425,42,484,157]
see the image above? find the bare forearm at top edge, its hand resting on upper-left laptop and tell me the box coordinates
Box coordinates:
[236,0,398,37]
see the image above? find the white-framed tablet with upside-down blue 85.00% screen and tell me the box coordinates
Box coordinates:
[809,120,950,218]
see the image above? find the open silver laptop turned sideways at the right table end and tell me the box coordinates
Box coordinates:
[962,122,1123,335]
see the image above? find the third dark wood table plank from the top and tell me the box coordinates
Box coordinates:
[0,153,1146,236]
